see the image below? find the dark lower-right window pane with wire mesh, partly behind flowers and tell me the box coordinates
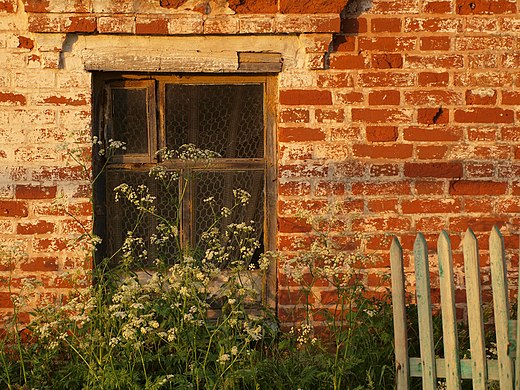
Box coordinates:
[194,171,264,266]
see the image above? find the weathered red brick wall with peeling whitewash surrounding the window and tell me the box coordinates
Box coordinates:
[0,0,520,322]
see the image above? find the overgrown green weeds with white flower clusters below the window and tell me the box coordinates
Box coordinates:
[0,141,394,390]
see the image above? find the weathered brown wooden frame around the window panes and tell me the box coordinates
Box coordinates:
[94,72,277,306]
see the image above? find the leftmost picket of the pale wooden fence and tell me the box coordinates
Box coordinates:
[390,237,410,390]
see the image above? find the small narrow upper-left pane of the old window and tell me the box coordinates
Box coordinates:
[111,88,148,154]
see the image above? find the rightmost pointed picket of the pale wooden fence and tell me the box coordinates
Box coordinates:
[489,226,513,390]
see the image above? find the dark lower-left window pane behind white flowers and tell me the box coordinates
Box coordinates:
[106,170,182,266]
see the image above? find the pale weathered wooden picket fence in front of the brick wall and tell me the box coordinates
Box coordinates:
[390,227,520,390]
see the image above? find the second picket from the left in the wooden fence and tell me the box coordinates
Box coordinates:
[413,233,437,390]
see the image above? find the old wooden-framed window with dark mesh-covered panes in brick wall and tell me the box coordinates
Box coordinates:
[95,73,276,274]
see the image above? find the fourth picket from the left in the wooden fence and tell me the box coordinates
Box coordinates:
[462,229,487,390]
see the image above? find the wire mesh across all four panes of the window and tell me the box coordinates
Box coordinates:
[105,79,265,266]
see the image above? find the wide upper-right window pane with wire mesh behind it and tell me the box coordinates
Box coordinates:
[166,84,264,158]
